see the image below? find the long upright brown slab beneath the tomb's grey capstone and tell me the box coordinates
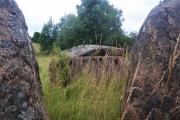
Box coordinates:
[69,56,124,81]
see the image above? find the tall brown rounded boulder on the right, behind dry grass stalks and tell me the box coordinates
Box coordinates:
[121,0,180,120]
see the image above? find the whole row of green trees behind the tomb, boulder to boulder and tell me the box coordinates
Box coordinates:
[32,0,137,52]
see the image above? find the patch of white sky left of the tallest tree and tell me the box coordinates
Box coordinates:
[16,0,80,36]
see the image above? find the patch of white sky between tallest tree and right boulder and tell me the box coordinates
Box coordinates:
[110,0,159,32]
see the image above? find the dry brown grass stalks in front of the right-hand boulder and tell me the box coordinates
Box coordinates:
[120,35,180,120]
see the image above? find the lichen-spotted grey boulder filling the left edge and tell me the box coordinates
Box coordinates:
[0,0,48,120]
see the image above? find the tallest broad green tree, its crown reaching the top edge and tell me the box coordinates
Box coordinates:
[77,0,123,45]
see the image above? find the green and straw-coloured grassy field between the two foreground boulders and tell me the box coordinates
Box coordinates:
[33,44,127,120]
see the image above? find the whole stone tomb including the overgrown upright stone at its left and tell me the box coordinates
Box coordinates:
[49,45,126,86]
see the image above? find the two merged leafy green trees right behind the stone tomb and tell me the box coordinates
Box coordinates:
[56,0,129,49]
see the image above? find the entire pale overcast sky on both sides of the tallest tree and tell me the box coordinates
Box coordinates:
[16,0,160,36]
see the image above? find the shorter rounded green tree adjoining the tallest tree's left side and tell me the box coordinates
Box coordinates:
[55,14,83,50]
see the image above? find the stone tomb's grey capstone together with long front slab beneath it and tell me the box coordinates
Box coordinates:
[67,45,125,80]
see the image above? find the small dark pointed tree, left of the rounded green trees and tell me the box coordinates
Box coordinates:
[39,18,60,52]
